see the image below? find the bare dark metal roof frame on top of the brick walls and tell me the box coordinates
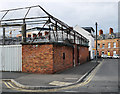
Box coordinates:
[0,5,89,46]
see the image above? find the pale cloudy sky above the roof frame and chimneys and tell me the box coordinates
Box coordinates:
[0,0,118,34]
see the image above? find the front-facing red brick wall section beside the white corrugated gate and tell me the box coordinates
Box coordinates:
[22,44,53,73]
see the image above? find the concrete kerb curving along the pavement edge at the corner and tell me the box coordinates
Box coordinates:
[3,60,99,90]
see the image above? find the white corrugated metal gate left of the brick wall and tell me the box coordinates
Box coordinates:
[0,45,22,71]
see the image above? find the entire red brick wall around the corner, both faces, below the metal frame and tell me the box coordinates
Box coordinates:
[22,43,89,74]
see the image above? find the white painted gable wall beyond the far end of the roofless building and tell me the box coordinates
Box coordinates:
[74,25,95,59]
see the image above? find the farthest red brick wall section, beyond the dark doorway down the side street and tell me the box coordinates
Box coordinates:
[79,46,89,64]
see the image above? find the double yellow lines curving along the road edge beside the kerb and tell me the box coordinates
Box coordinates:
[3,60,104,92]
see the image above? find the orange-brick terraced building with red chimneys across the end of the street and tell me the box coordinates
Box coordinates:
[95,28,120,56]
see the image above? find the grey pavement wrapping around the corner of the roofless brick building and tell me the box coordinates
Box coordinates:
[2,59,101,86]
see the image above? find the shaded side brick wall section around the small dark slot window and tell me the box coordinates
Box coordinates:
[53,45,73,72]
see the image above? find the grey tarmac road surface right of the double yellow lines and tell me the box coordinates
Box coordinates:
[59,59,118,94]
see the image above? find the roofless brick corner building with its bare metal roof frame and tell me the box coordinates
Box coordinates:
[0,5,89,73]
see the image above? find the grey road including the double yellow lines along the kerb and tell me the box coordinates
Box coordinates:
[3,59,118,94]
